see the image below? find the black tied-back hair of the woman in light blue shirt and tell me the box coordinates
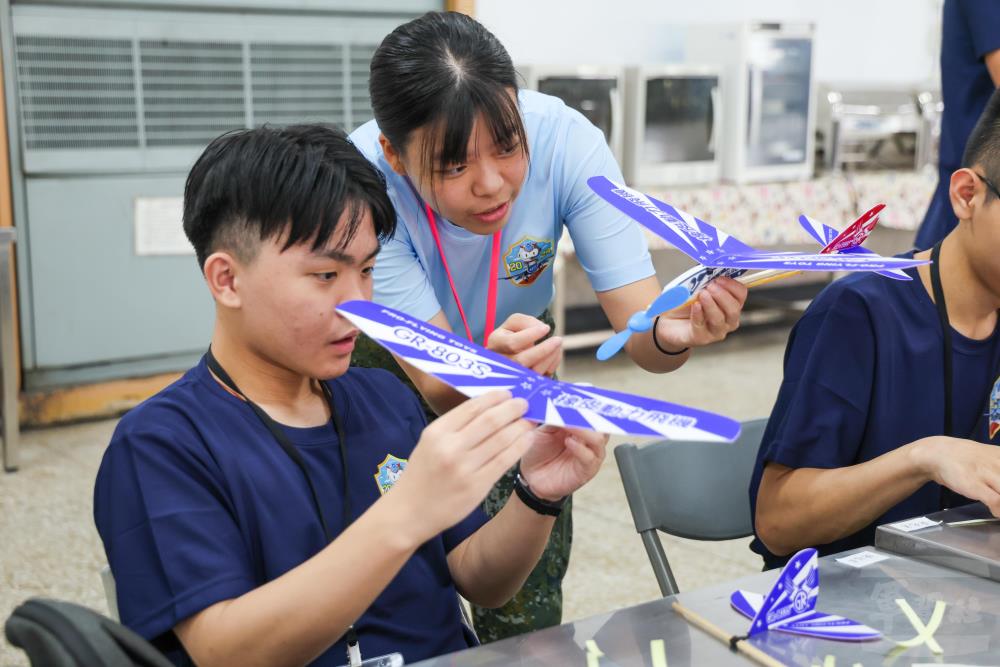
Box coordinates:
[368,12,528,179]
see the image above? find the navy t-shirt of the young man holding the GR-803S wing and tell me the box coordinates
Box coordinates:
[94,359,487,665]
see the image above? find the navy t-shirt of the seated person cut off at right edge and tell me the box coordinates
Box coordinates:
[750,253,1000,568]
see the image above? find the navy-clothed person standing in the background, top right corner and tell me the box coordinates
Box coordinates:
[916,0,1000,248]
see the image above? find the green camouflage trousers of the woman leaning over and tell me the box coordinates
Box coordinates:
[351,311,573,644]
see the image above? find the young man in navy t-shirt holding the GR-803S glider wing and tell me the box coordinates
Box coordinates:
[94,125,607,666]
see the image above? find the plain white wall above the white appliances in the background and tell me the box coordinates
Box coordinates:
[475,0,941,84]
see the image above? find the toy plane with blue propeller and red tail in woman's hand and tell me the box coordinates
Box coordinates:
[587,176,929,361]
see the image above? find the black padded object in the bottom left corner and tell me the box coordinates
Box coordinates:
[4,598,173,667]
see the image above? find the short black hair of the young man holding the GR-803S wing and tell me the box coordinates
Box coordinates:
[184,124,396,268]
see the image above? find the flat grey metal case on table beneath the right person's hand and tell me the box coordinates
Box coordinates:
[875,503,1000,581]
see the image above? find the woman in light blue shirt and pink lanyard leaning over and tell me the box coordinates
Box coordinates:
[351,12,746,641]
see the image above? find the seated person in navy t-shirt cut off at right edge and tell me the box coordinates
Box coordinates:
[750,93,1000,568]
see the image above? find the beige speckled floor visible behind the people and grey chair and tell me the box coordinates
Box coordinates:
[0,328,787,666]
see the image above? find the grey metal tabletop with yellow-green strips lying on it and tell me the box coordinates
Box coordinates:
[419,547,1000,667]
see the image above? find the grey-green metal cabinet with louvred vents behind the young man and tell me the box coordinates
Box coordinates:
[0,0,442,389]
